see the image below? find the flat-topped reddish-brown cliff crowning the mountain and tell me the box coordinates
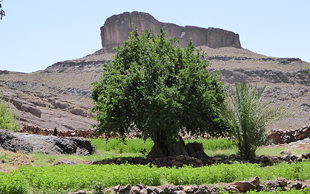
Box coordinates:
[100,12,241,53]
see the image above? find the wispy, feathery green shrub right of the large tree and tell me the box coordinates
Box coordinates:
[222,82,292,160]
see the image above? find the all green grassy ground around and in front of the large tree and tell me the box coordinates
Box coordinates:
[0,139,310,193]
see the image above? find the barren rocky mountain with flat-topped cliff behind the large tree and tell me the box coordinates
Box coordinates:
[0,12,310,130]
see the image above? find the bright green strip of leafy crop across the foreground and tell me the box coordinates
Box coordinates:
[0,161,310,193]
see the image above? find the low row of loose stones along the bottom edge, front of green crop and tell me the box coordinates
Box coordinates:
[68,177,309,194]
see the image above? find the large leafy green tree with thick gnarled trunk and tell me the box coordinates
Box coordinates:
[92,26,225,157]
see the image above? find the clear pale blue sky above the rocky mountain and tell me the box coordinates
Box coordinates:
[0,0,310,72]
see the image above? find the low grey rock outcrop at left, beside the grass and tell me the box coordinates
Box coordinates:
[0,129,98,155]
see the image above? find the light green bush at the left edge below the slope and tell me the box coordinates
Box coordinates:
[0,97,20,131]
